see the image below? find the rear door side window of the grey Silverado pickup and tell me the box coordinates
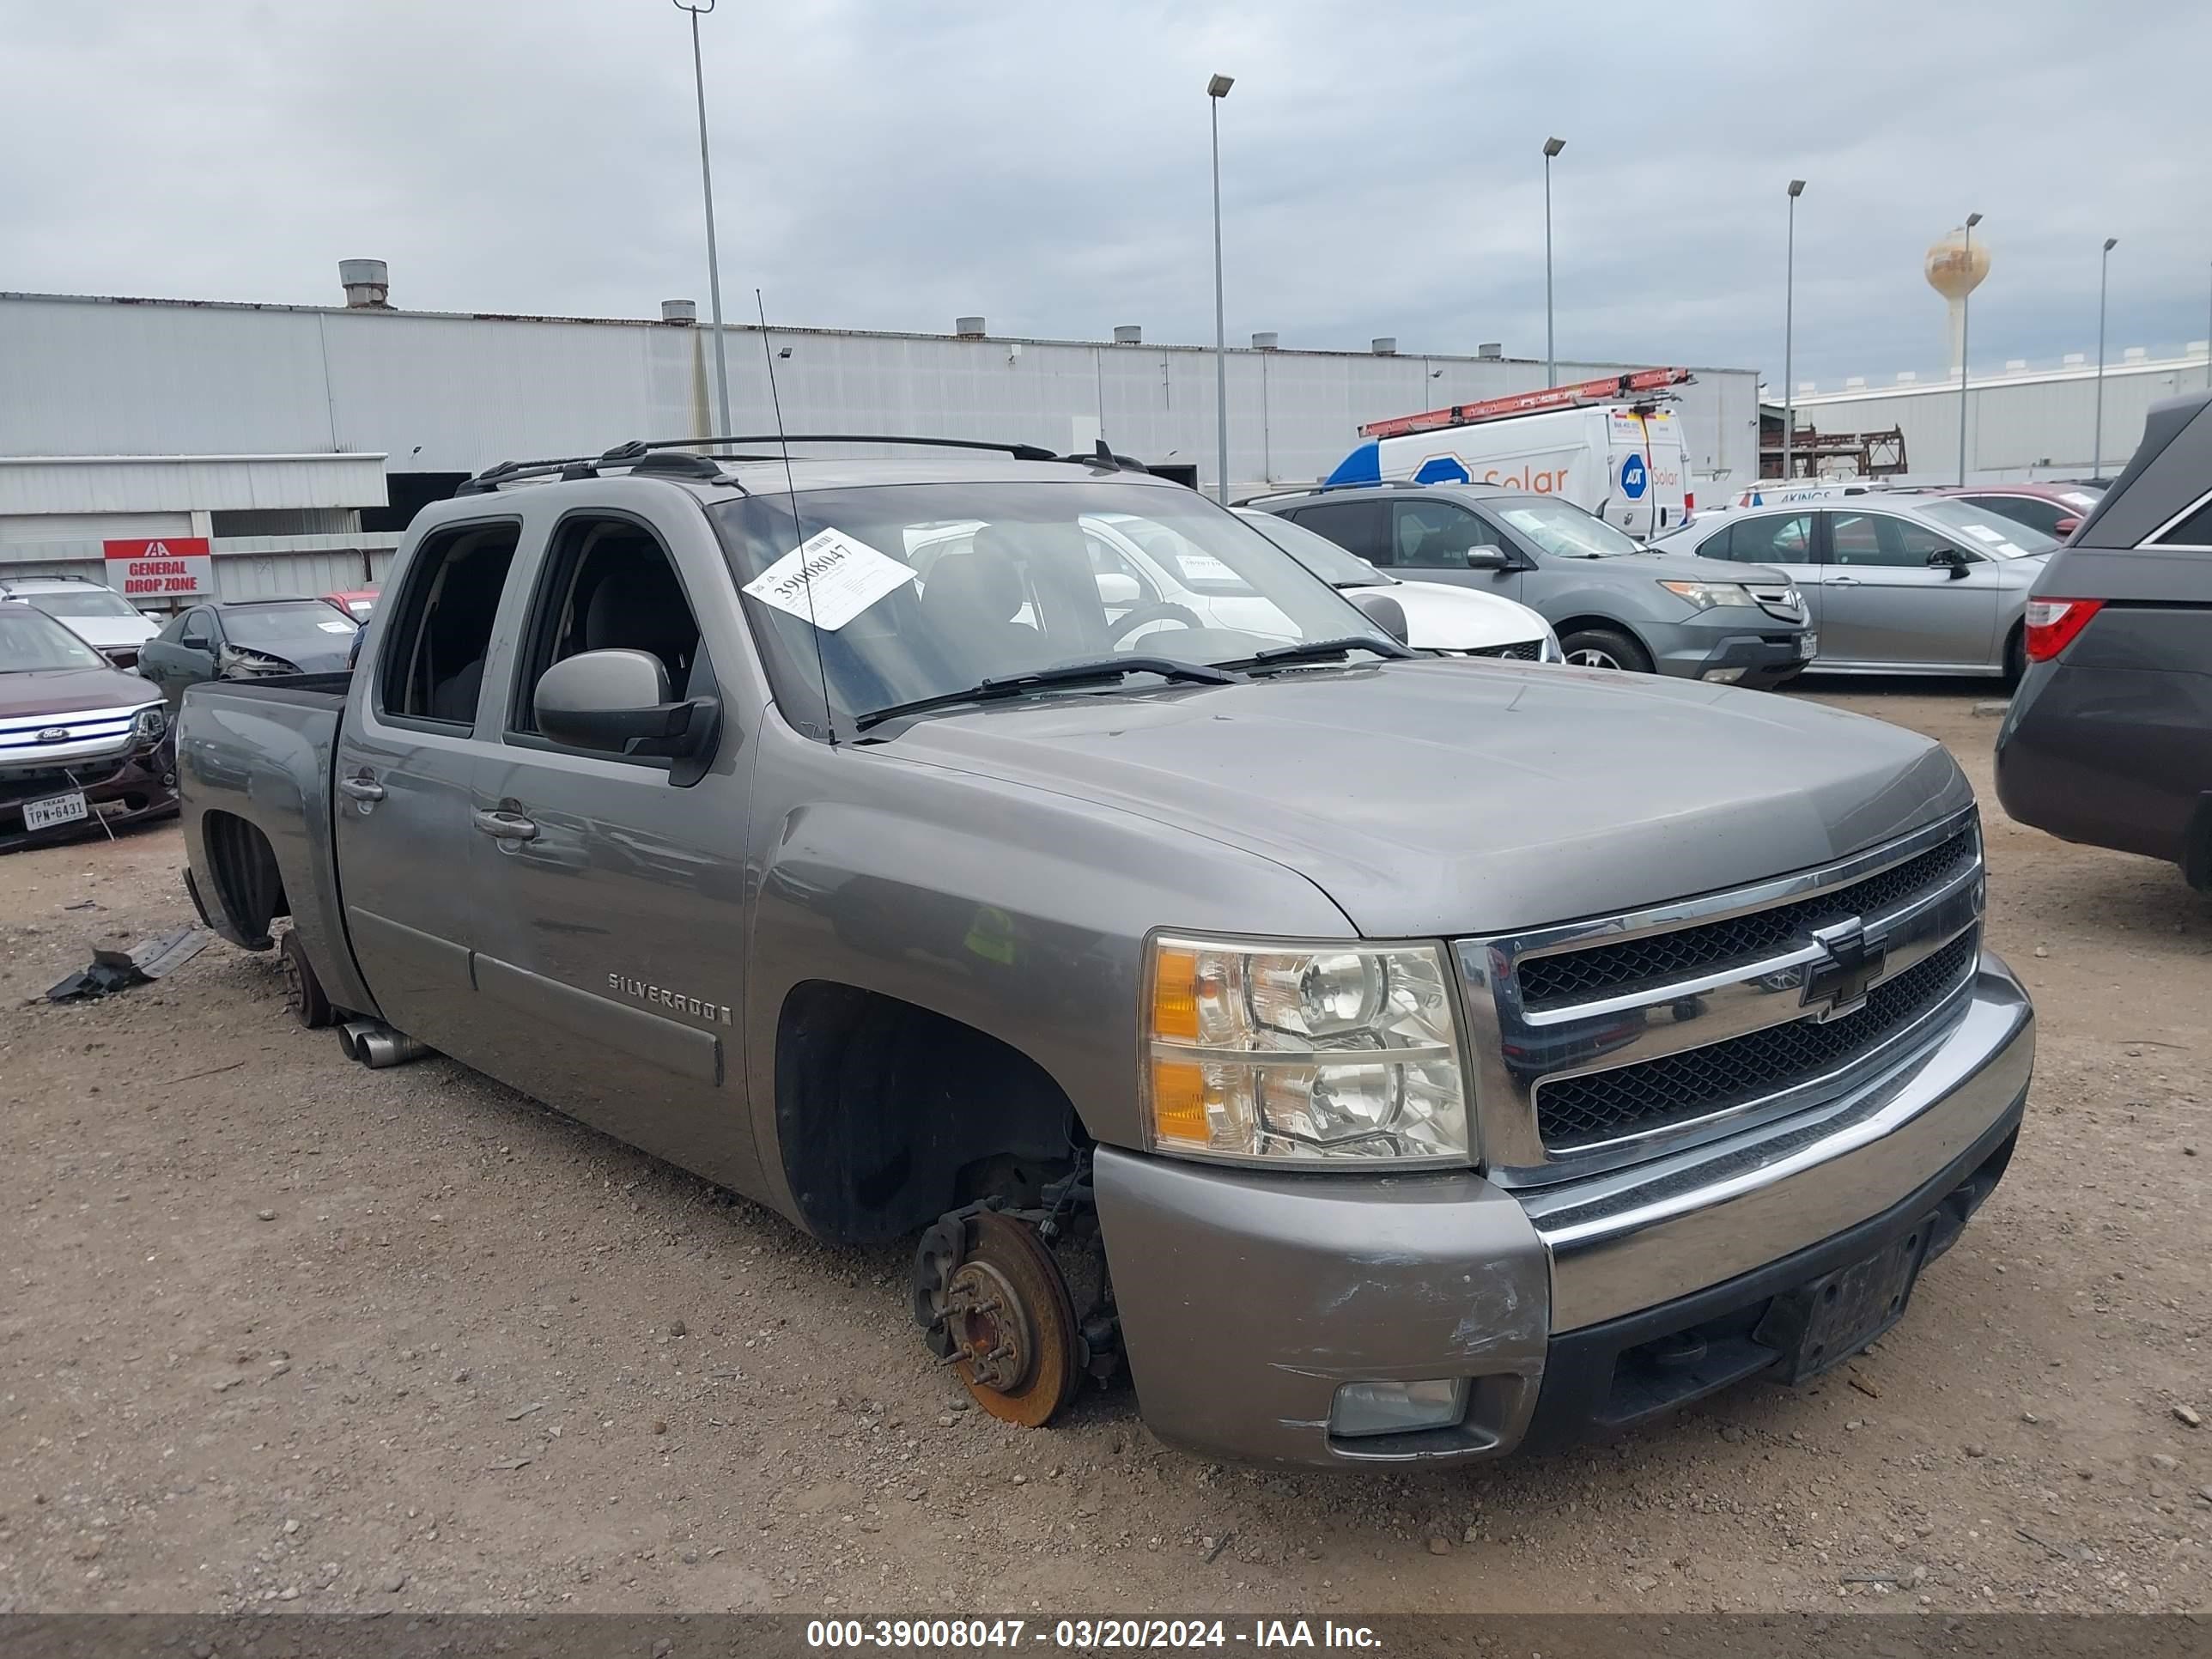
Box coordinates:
[376,525,520,728]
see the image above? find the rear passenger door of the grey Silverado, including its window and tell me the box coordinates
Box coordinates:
[331,515,520,1060]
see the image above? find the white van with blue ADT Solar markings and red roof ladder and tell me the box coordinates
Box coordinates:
[1325,369,1694,538]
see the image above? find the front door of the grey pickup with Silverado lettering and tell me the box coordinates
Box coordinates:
[469,493,757,1186]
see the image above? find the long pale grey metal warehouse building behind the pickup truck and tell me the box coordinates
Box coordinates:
[0,261,1759,610]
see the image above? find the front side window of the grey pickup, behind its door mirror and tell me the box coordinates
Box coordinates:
[507,515,710,737]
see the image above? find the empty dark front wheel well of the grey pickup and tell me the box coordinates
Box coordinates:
[776,980,1084,1243]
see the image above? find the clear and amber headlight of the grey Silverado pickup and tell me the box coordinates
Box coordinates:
[1144,938,1468,1166]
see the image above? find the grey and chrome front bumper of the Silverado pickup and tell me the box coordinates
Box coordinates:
[1095,953,2035,1467]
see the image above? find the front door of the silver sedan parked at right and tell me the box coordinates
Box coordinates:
[1820,508,2000,672]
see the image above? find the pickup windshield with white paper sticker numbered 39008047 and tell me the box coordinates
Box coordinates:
[710,480,1402,732]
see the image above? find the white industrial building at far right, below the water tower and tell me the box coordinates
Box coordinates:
[1767,341,2208,484]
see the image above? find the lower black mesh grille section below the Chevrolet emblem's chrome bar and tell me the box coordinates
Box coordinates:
[1535,933,1980,1152]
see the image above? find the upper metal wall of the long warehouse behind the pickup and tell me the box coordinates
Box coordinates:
[0,295,1759,500]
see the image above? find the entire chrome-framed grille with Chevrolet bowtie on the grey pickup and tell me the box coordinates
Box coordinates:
[1455,807,1984,1186]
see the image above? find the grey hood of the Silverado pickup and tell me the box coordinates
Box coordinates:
[884,667,1973,938]
